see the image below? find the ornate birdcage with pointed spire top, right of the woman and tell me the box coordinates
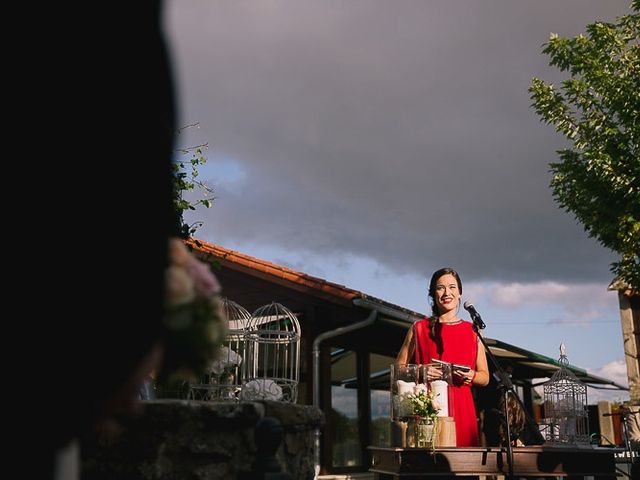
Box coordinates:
[541,343,589,445]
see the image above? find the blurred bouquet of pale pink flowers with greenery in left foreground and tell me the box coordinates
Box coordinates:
[160,238,227,386]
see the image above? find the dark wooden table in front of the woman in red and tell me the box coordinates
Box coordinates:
[368,446,622,480]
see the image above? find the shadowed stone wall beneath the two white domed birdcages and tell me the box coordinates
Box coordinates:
[82,400,324,480]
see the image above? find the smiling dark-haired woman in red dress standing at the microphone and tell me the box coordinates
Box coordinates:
[396,268,489,447]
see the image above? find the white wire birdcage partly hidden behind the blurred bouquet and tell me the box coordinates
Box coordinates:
[188,298,251,401]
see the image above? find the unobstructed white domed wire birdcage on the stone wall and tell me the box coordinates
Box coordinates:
[241,302,300,403]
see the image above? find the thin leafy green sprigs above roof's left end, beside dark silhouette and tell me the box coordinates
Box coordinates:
[172,137,215,239]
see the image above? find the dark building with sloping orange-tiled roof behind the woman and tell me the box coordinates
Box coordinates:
[187,240,625,473]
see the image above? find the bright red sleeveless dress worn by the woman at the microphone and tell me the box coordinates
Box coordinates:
[414,319,478,447]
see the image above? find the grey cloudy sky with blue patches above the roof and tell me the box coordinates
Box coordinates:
[166,0,630,402]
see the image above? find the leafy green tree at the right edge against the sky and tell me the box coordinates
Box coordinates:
[529,0,640,290]
